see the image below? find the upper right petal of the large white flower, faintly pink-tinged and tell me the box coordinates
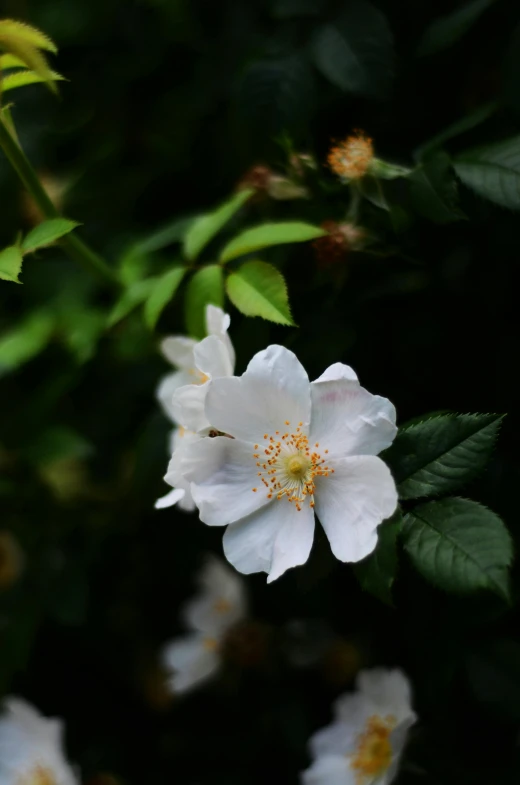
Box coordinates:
[310,376,397,457]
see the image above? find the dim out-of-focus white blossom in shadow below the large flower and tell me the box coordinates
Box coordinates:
[163,557,247,693]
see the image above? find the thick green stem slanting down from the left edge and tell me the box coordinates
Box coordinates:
[0,113,121,286]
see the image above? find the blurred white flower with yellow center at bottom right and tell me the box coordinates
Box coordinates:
[301,668,417,785]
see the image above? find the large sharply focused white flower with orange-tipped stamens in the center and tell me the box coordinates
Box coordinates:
[181,346,397,582]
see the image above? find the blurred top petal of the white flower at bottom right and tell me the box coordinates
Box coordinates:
[356,668,413,722]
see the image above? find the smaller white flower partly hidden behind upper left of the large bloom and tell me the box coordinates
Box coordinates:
[157,305,235,430]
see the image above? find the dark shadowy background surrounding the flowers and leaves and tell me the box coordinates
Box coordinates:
[0,0,520,785]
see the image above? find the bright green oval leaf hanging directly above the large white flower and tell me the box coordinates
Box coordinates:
[226,261,294,325]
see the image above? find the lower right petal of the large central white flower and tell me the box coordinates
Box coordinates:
[315,455,397,562]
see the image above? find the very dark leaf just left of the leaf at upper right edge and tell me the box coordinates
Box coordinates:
[408,151,465,224]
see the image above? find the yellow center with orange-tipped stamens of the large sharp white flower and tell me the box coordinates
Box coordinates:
[252,420,334,510]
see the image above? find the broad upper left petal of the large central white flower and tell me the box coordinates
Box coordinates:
[206,345,310,442]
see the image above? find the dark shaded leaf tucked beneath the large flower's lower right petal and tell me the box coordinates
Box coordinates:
[354,510,403,605]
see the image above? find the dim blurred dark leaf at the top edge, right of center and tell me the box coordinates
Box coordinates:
[311,0,394,98]
